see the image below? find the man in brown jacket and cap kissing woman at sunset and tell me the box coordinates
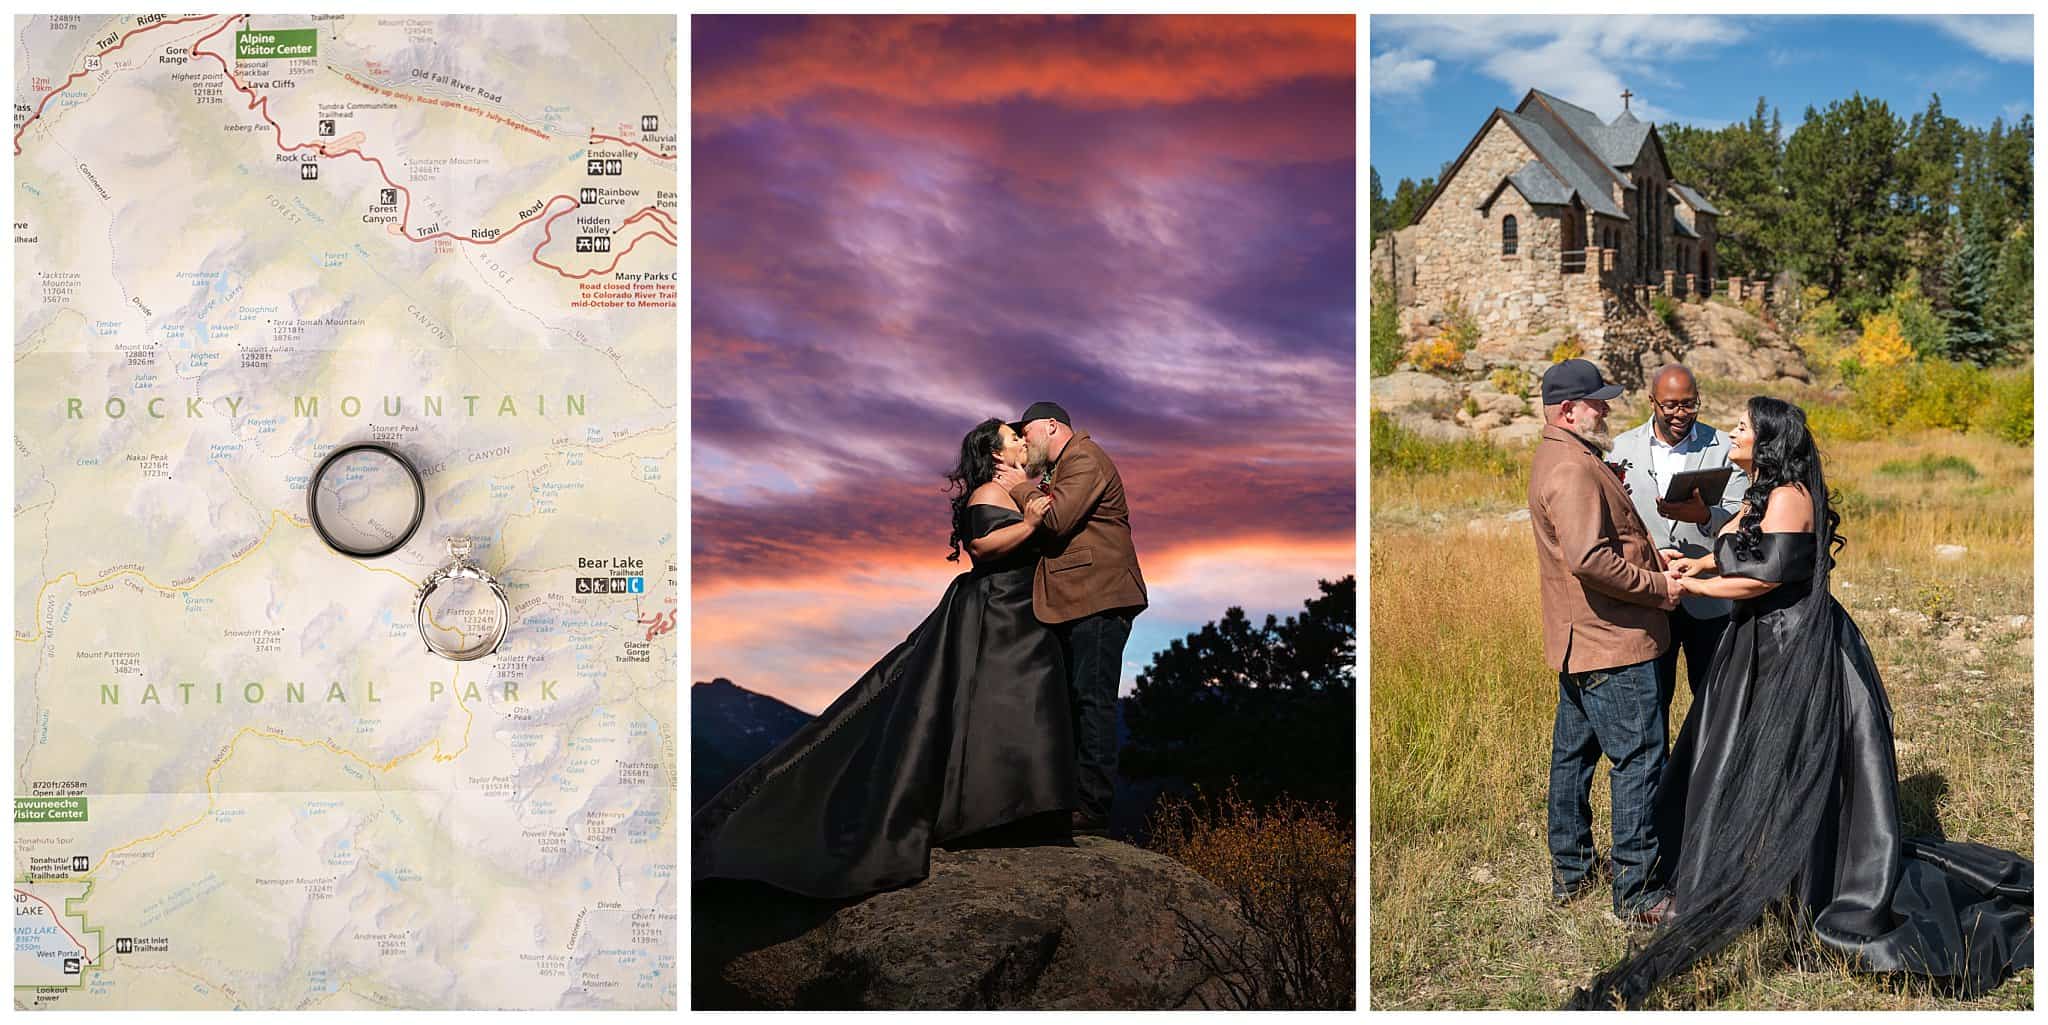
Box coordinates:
[997,402,1147,834]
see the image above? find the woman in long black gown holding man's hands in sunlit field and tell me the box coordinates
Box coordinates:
[1569,396,2034,1009]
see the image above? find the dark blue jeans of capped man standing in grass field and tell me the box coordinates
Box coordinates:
[1550,658,1665,914]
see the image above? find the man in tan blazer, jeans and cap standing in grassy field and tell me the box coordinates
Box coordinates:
[1530,359,1679,925]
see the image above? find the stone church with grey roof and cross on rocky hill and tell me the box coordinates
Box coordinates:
[1372,90,1720,359]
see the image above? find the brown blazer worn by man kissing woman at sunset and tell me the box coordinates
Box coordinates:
[1010,431,1147,623]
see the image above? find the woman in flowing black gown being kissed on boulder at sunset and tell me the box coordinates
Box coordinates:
[690,420,1079,900]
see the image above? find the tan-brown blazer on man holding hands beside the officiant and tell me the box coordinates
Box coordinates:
[1530,424,1671,672]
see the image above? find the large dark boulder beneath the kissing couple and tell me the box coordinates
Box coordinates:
[690,836,1247,1011]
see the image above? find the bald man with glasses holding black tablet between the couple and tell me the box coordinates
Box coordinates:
[1610,363,1749,707]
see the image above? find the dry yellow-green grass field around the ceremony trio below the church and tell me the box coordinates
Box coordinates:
[1368,392,2034,1009]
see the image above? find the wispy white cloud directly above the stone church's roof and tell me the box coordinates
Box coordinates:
[1372,14,1747,121]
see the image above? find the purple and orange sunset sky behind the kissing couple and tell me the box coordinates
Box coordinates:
[690,16,1356,711]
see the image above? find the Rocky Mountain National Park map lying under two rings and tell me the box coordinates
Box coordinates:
[12,14,682,1011]
